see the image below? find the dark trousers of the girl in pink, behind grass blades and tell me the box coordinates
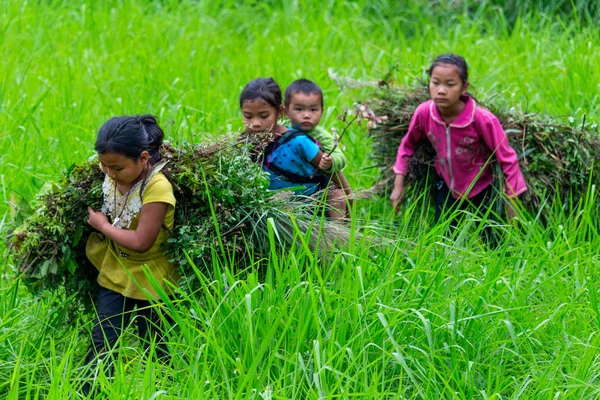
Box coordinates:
[433,177,495,244]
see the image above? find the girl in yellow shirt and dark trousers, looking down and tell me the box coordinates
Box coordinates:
[83,115,178,394]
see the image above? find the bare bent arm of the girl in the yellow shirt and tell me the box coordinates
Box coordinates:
[88,203,169,253]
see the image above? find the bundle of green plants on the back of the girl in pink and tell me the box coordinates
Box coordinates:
[369,84,600,213]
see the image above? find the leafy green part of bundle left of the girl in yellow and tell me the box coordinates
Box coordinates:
[8,162,104,303]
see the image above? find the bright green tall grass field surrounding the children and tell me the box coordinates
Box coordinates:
[0,0,600,400]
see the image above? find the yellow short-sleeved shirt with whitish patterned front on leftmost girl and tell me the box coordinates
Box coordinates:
[86,172,179,300]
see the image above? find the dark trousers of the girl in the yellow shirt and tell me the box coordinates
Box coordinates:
[83,287,169,394]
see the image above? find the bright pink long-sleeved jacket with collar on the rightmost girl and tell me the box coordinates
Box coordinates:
[393,96,527,199]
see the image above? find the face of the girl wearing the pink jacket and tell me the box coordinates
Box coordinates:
[429,64,469,114]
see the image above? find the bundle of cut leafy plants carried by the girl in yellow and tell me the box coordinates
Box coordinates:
[8,137,348,311]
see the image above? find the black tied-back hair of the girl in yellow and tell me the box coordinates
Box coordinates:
[96,114,165,165]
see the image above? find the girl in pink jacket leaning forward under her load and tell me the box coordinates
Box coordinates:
[390,54,527,223]
